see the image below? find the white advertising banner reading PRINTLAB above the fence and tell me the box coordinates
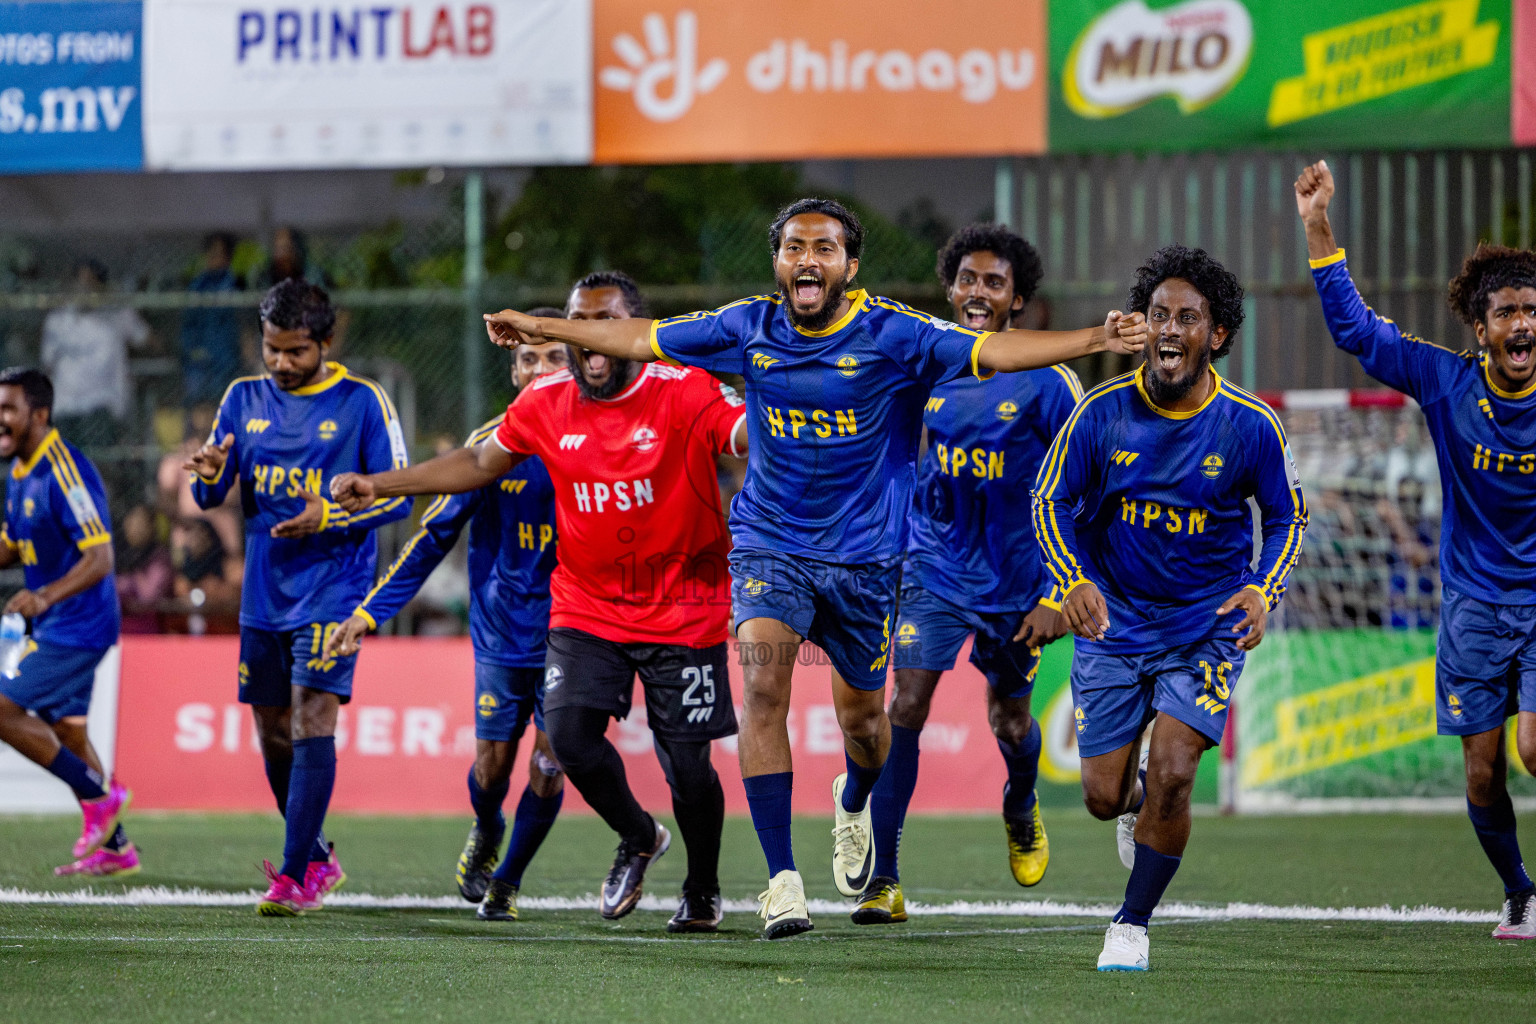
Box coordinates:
[144,0,591,170]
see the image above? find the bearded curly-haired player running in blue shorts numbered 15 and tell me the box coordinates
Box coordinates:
[1034,246,1307,970]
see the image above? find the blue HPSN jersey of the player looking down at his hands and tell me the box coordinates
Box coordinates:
[192,362,410,629]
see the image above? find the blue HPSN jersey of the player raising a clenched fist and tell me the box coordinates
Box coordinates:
[1312,249,1536,605]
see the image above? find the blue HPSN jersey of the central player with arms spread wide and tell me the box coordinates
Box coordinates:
[651,290,991,565]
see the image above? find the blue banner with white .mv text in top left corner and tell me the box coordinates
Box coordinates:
[0,2,144,173]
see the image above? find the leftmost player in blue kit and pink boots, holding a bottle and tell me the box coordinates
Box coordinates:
[0,367,138,877]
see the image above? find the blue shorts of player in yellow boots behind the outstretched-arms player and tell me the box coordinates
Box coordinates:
[892,586,1040,700]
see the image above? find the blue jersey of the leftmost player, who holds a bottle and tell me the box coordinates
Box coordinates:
[0,430,121,649]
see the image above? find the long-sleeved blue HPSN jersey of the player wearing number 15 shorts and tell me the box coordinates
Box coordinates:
[1034,367,1307,654]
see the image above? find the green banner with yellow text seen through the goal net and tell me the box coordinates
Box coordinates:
[1236,629,1536,809]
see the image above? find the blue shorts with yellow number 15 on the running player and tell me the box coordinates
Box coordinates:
[1072,637,1247,757]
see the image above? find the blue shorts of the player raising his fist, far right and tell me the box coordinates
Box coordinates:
[1435,586,1536,735]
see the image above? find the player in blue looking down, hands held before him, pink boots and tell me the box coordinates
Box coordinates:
[186,279,410,917]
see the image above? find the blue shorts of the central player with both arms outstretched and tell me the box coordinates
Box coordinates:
[731,548,902,689]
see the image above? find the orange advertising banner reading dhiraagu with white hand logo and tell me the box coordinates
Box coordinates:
[593,0,1048,163]
